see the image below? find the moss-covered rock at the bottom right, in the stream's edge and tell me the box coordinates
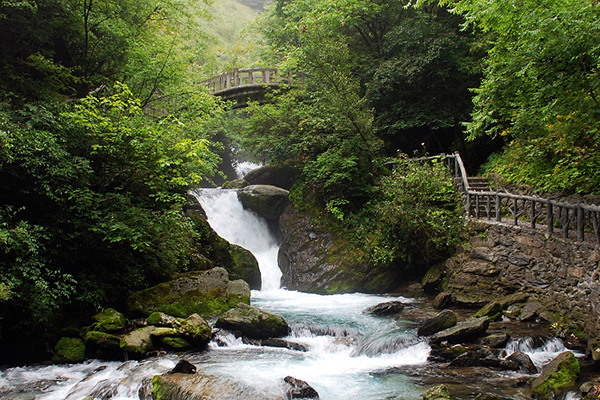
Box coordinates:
[531,351,579,400]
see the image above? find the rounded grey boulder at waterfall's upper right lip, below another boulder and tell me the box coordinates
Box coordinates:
[238,185,289,219]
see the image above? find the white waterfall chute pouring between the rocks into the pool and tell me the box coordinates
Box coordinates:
[194,189,281,291]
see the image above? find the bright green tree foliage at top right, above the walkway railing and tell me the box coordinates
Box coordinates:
[424,0,600,193]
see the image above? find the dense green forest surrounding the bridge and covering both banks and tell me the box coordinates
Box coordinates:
[0,0,600,362]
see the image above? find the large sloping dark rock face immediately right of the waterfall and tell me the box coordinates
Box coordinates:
[277,205,403,294]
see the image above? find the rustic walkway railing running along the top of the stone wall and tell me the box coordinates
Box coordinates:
[419,152,600,244]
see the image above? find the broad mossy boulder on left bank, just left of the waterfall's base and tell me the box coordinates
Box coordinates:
[127,268,250,318]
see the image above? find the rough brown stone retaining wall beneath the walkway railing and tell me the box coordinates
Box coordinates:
[446,222,600,337]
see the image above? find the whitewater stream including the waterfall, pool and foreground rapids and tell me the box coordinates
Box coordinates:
[0,176,576,400]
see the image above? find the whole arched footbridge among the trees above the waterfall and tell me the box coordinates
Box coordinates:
[201,68,306,108]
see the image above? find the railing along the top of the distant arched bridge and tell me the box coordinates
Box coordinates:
[201,68,306,93]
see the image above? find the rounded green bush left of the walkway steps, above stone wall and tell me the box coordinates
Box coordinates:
[347,159,464,264]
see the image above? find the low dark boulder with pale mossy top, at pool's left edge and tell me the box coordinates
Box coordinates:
[216,303,290,339]
